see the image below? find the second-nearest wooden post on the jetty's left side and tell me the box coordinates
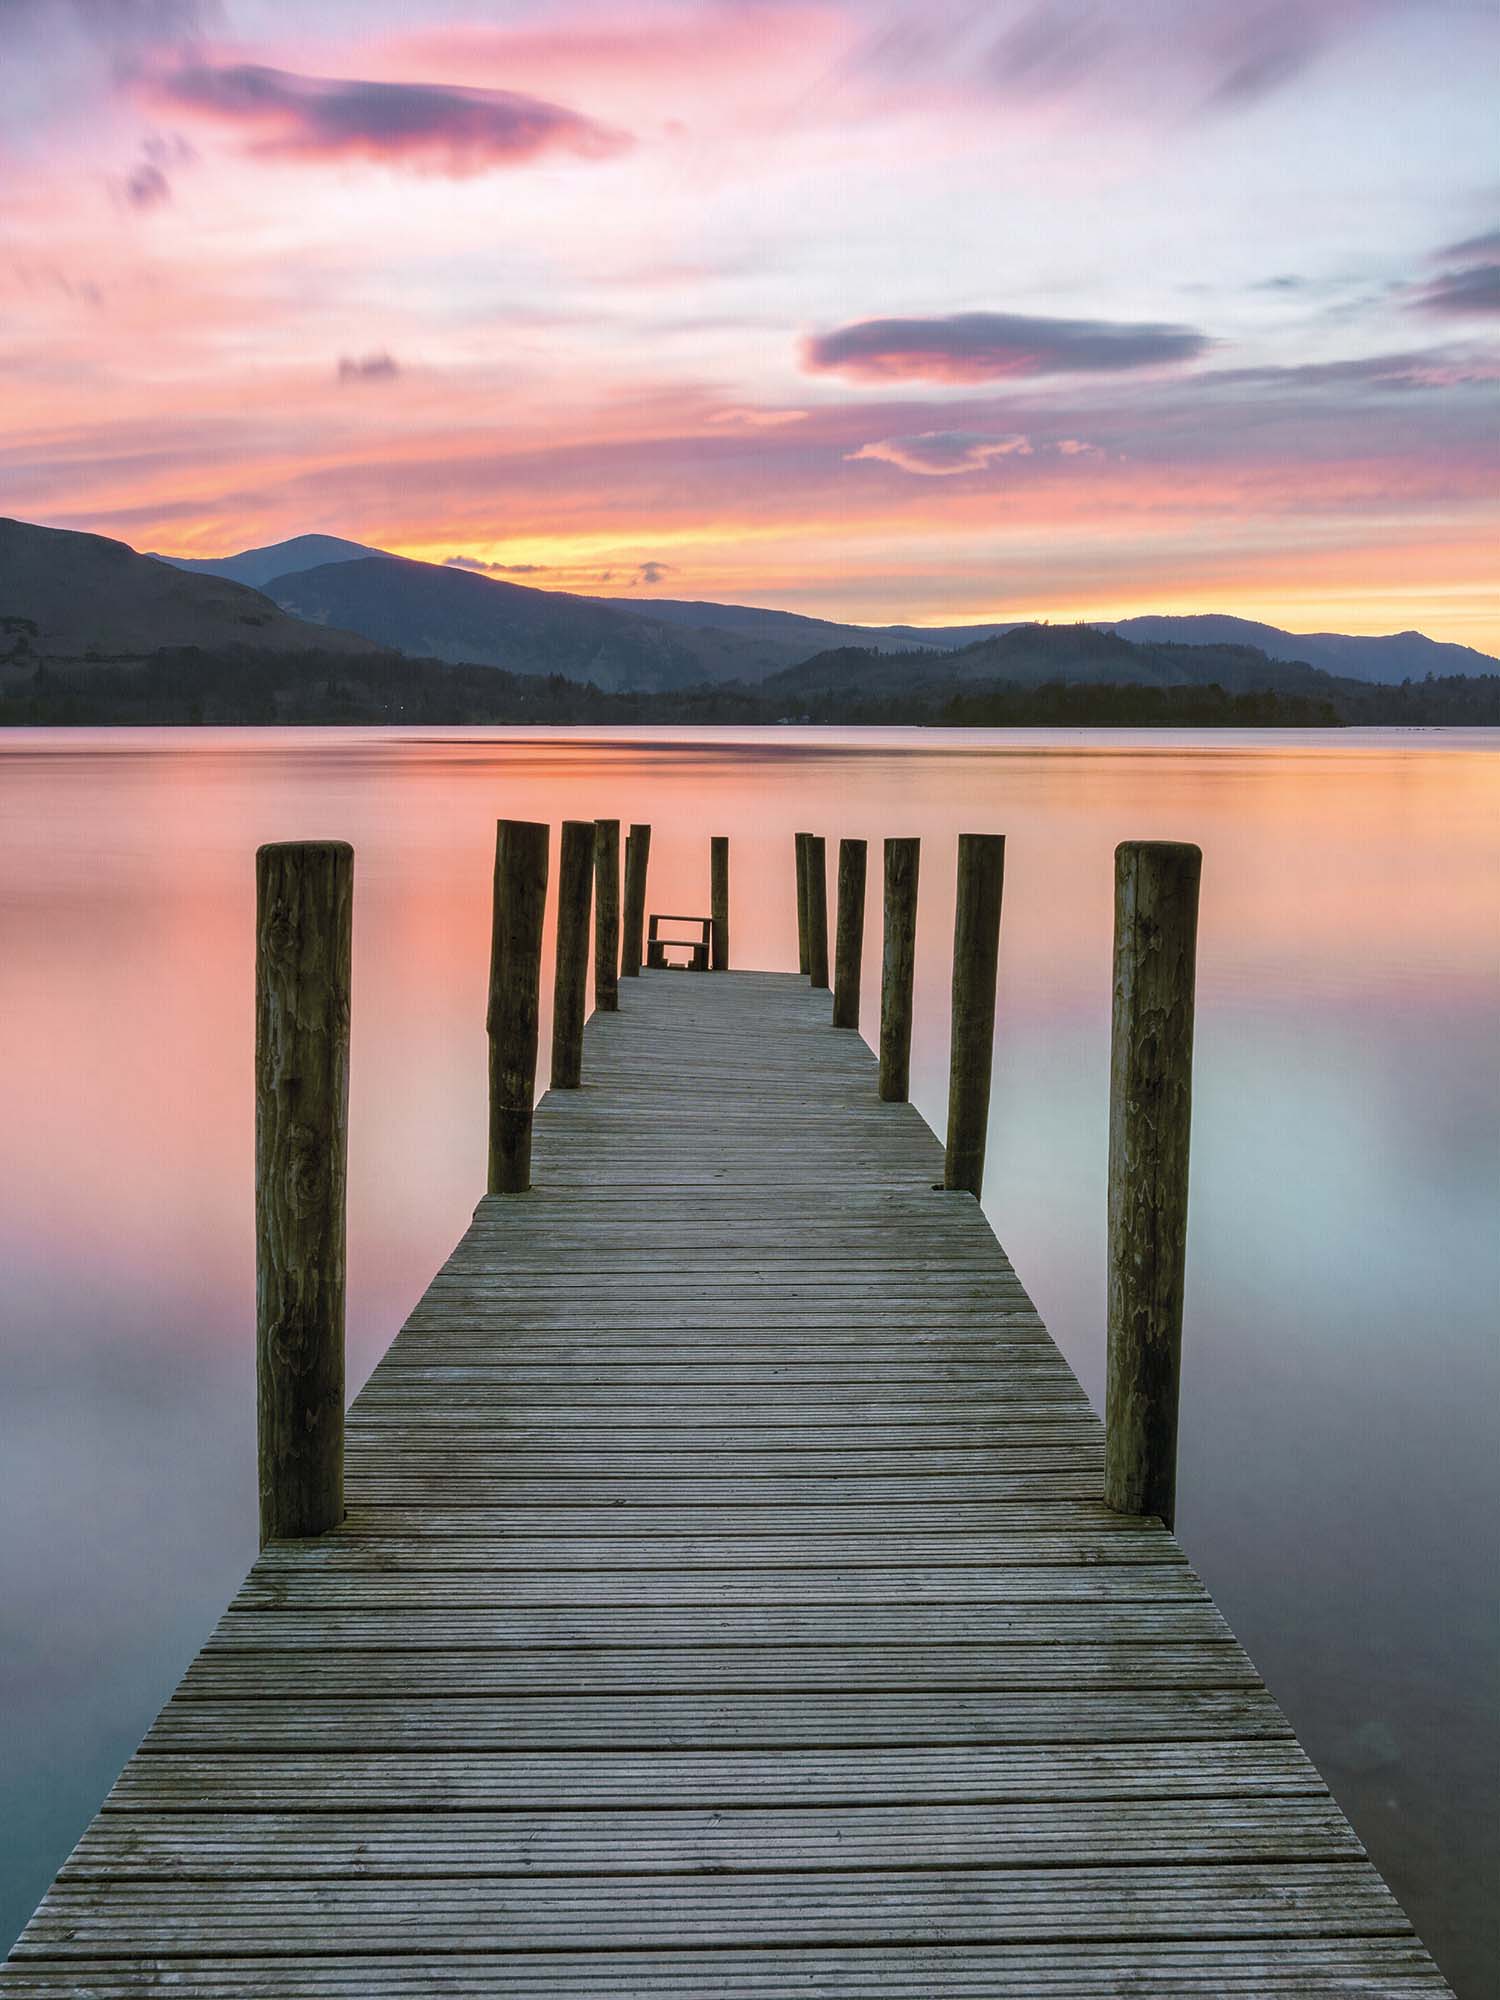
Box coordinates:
[486,820,550,1194]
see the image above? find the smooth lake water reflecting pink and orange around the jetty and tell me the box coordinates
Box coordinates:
[0,728,1500,1996]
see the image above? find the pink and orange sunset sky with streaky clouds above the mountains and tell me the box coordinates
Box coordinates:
[0,0,1500,652]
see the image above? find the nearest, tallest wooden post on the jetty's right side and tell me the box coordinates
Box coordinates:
[1104,840,1202,1528]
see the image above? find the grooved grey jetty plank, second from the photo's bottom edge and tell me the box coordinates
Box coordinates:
[16,1862,1410,1958]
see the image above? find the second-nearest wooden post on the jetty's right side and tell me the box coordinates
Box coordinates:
[942,834,1006,1200]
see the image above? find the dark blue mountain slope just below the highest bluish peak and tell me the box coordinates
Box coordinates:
[266,556,812,692]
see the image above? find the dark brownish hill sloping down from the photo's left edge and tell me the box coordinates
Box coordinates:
[0,520,382,676]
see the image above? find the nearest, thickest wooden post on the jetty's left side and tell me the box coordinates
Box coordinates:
[256,840,354,1548]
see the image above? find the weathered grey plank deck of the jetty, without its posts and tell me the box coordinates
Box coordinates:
[0,824,1448,2000]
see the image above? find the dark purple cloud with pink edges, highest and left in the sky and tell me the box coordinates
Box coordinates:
[156,62,630,180]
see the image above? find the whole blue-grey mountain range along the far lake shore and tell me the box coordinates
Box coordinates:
[0,522,1500,720]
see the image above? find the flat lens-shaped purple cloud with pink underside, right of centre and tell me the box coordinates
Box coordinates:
[802,312,1210,382]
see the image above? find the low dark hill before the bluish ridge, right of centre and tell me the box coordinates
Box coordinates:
[762,624,1332,698]
